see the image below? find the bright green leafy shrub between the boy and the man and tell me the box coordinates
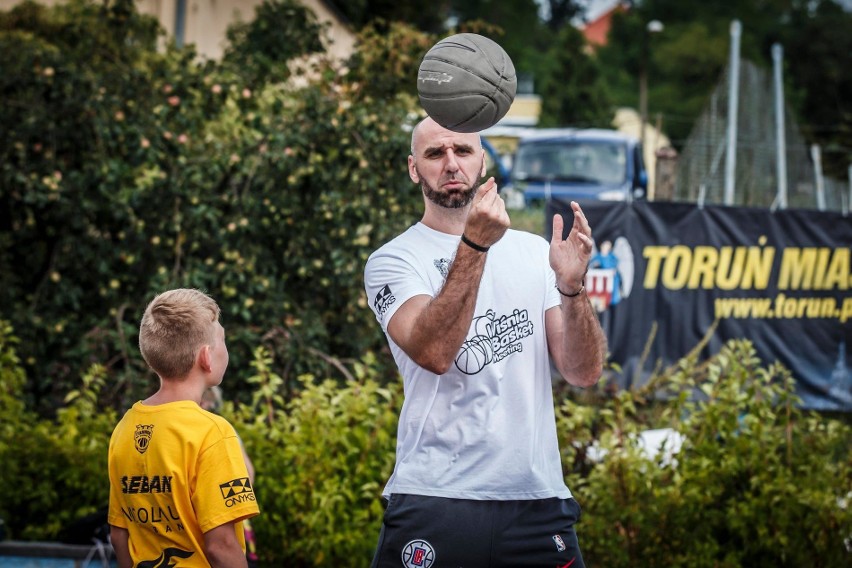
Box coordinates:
[226,349,402,566]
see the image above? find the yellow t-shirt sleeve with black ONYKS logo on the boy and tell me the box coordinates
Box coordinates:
[192,424,260,532]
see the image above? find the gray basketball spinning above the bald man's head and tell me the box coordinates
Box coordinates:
[417,33,518,132]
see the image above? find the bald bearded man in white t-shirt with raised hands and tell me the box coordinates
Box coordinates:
[365,118,606,568]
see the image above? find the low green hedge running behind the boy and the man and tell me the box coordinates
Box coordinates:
[0,324,852,568]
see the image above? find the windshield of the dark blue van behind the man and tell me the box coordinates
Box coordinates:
[512,140,627,185]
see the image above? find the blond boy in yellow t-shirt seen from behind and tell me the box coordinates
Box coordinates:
[108,289,260,568]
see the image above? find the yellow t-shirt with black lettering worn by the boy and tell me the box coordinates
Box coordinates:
[109,401,260,568]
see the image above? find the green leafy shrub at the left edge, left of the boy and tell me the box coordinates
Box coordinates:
[0,321,116,540]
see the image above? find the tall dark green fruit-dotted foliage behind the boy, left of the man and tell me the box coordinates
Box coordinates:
[0,0,420,409]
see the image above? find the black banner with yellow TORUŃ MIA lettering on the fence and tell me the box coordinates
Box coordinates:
[545,200,852,412]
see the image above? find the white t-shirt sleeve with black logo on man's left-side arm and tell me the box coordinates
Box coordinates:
[364,251,434,332]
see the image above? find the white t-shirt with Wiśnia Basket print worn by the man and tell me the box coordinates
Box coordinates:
[365,223,571,500]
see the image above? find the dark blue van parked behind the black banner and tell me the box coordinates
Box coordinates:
[508,128,648,204]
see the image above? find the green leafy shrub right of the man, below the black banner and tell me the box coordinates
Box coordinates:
[559,341,852,567]
